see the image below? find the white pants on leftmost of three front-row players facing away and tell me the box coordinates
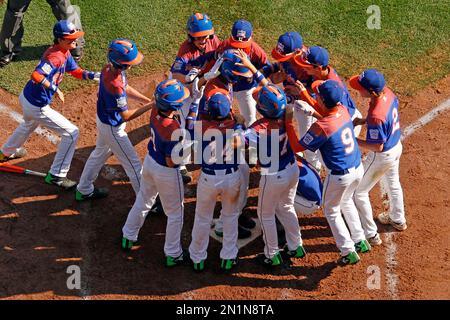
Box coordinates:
[122,154,184,257]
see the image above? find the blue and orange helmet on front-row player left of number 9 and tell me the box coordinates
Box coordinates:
[253,84,287,119]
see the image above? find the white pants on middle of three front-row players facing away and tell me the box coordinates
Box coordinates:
[189,170,241,263]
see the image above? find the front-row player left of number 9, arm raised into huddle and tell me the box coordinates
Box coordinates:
[237,51,306,267]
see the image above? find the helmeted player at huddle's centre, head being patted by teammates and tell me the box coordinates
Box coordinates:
[187,49,256,239]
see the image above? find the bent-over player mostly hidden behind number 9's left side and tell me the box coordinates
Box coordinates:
[294,158,323,216]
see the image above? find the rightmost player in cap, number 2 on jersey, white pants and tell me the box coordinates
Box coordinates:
[349,69,407,245]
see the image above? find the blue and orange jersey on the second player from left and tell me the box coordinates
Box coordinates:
[97,64,128,127]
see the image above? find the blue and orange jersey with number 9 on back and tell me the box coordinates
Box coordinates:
[300,105,361,171]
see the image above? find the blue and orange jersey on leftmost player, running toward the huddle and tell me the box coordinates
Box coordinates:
[23,45,78,108]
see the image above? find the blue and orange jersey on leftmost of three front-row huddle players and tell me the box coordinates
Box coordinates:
[147,108,180,167]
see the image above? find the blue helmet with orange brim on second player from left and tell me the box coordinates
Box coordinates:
[108,38,144,69]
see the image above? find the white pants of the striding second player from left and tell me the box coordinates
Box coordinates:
[77,117,142,195]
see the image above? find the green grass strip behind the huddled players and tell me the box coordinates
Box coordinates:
[0,0,450,94]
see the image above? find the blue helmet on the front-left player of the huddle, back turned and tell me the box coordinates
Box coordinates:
[155,79,189,111]
